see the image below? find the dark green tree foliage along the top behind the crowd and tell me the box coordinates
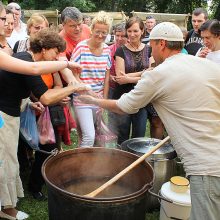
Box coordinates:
[9,0,220,19]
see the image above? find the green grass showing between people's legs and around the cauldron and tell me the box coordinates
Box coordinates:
[18,123,159,220]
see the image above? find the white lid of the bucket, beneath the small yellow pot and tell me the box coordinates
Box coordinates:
[161,182,191,206]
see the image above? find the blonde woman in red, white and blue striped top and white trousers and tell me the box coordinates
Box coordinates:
[71,11,111,147]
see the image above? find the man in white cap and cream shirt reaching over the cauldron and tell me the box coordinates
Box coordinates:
[79,22,220,220]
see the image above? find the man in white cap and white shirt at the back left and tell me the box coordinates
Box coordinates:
[7,2,28,49]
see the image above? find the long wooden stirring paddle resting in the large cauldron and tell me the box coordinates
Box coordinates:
[84,136,170,197]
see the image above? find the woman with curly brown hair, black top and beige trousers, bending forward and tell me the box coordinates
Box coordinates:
[0,29,85,219]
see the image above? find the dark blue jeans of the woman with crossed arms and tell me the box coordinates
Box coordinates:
[117,108,147,144]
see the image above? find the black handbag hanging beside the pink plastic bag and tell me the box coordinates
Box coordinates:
[49,105,66,126]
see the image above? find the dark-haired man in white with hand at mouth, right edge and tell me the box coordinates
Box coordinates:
[197,19,220,64]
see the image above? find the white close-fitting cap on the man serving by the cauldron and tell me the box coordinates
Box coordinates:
[149,22,184,41]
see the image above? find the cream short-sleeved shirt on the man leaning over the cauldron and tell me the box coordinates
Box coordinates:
[117,54,220,177]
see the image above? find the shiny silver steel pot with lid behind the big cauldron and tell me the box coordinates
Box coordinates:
[121,138,177,210]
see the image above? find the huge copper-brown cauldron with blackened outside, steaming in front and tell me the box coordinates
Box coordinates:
[42,148,154,220]
